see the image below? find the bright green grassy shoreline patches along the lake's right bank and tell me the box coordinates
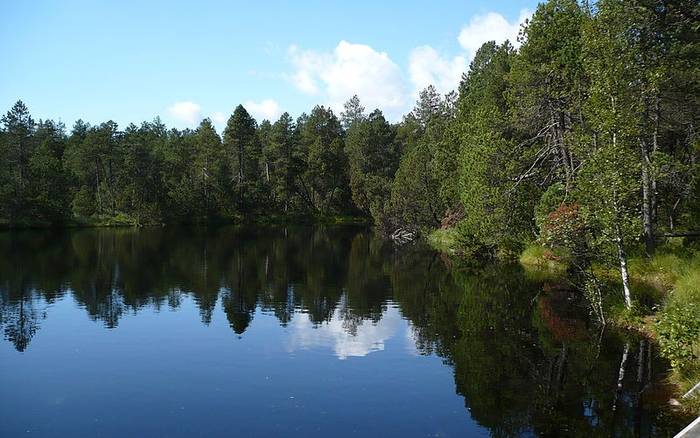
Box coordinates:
[425,229,700,416]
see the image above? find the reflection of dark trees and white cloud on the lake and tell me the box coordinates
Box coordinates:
[0,227,678,436]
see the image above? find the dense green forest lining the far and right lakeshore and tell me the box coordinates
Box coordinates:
[0,0,700,386]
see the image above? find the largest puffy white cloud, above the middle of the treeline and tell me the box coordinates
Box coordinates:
[288,41,406,116]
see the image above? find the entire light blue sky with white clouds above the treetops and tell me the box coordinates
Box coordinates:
[0,0,537,129]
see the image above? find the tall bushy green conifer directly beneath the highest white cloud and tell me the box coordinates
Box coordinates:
[456,42,534,253]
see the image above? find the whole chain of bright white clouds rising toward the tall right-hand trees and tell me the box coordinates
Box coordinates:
[286,10,532,119]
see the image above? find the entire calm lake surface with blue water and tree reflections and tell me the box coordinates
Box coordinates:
[0,227,682,437]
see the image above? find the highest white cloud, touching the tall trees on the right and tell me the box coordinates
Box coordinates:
[457,9,532,60]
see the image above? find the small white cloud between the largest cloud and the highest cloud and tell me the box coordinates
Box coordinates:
[408,46,467,97]
